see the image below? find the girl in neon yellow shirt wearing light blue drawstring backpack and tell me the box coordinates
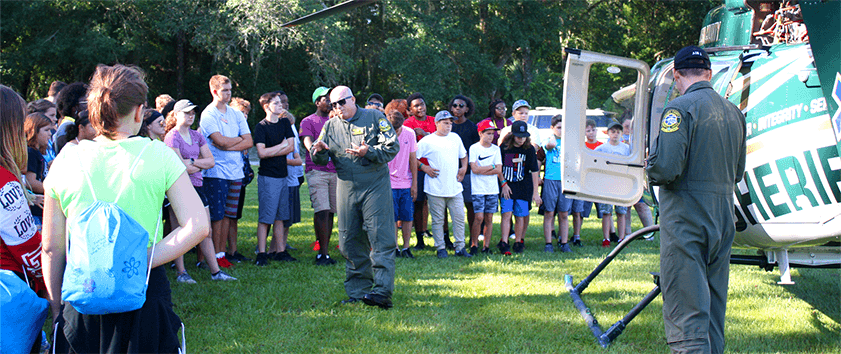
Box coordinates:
[42,64,209,353]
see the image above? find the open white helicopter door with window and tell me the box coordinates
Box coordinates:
[561,49,649,206]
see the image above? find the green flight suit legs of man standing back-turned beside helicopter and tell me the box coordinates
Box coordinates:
[660,188,736,353]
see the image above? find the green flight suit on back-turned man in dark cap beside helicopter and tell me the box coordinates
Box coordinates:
[646,81,745,353]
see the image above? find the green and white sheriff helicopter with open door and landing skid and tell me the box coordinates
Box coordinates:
[561,0,841,347]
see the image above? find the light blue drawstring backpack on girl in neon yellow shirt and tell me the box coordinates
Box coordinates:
[61,142,161,315]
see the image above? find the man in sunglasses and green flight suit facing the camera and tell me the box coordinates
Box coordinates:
[312,86,400,309]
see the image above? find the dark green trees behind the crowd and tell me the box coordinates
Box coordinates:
[0,0,721,125]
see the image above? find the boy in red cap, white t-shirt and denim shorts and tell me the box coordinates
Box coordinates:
[469,121,502,256]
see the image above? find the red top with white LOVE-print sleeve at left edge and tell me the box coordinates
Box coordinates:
[0,167,46,293]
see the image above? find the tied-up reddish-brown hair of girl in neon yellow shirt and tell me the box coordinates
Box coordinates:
[88,64,149,139]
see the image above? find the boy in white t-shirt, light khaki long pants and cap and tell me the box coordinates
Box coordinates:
[416,111,472,258]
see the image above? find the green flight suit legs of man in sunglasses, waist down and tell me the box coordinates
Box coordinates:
[336,172,397,298]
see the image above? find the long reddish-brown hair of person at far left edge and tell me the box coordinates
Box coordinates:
[0,85,27,181]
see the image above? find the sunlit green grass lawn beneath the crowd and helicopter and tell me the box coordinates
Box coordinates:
[169,183,841,353]
